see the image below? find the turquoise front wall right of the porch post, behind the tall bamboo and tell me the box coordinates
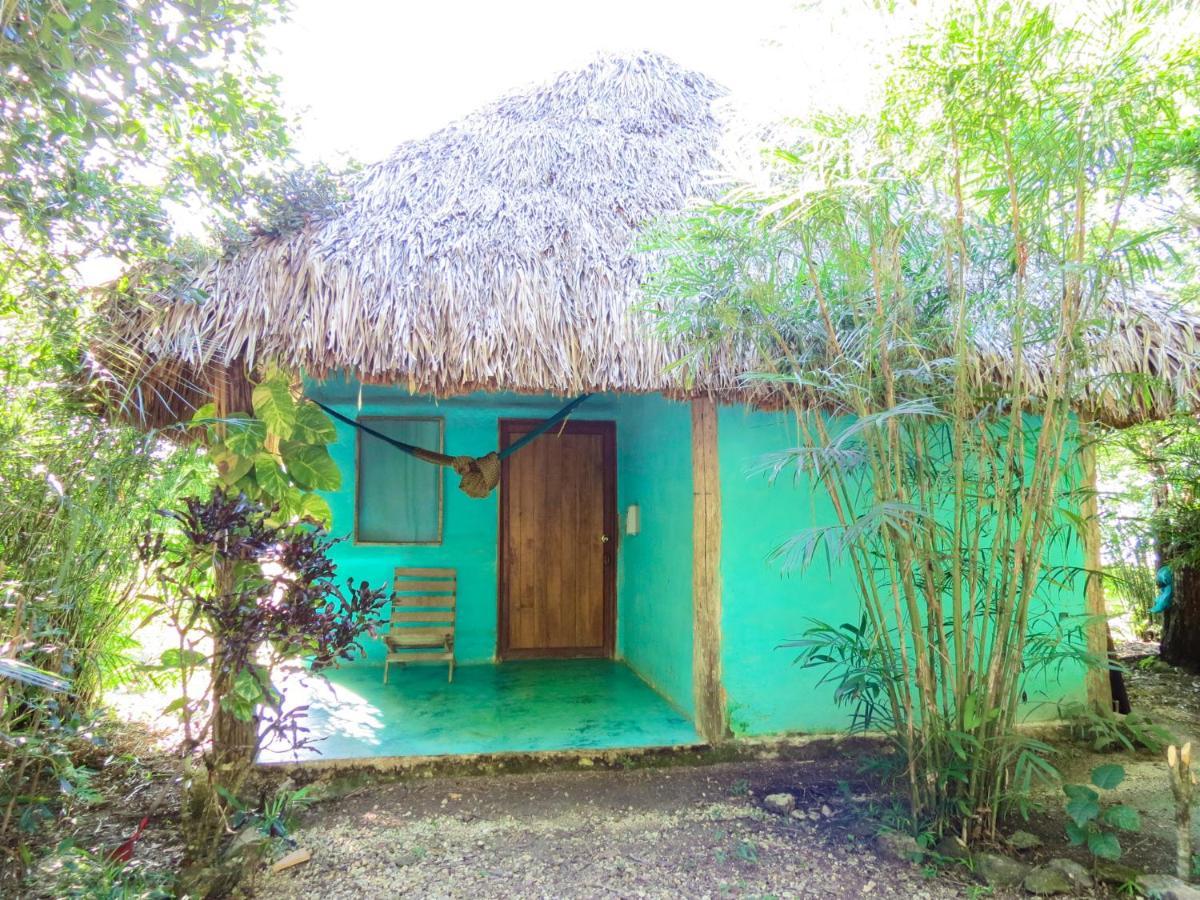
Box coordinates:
[719,407,1085,734]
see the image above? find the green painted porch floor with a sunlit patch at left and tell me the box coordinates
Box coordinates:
[260,660,700,762]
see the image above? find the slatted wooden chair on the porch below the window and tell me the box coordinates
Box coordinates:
[383,569,457,684]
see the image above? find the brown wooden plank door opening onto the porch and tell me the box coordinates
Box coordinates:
[498,419,617,659]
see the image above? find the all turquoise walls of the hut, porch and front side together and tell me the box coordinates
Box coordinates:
[308,382,1084,734]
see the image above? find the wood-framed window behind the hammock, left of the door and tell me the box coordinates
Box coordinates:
[354,416,443,544]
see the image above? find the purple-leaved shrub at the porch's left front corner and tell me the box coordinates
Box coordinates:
[139,492,386,751]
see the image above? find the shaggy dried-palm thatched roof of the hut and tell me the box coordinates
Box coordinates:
[96,53,1200,422]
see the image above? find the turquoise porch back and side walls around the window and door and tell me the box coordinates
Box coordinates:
[307,380,691,715]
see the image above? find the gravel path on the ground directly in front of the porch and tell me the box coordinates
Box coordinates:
[257,758,966,900]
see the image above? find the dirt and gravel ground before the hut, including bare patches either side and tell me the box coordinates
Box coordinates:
[18,644,1200,900]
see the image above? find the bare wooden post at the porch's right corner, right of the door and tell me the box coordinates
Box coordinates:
[691,398,730,744]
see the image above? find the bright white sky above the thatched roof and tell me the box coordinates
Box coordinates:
[268,0,928,164]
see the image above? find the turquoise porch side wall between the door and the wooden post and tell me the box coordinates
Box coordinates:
[617,395,695,715]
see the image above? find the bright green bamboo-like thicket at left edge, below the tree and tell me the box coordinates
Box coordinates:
[0,388,206,868]
